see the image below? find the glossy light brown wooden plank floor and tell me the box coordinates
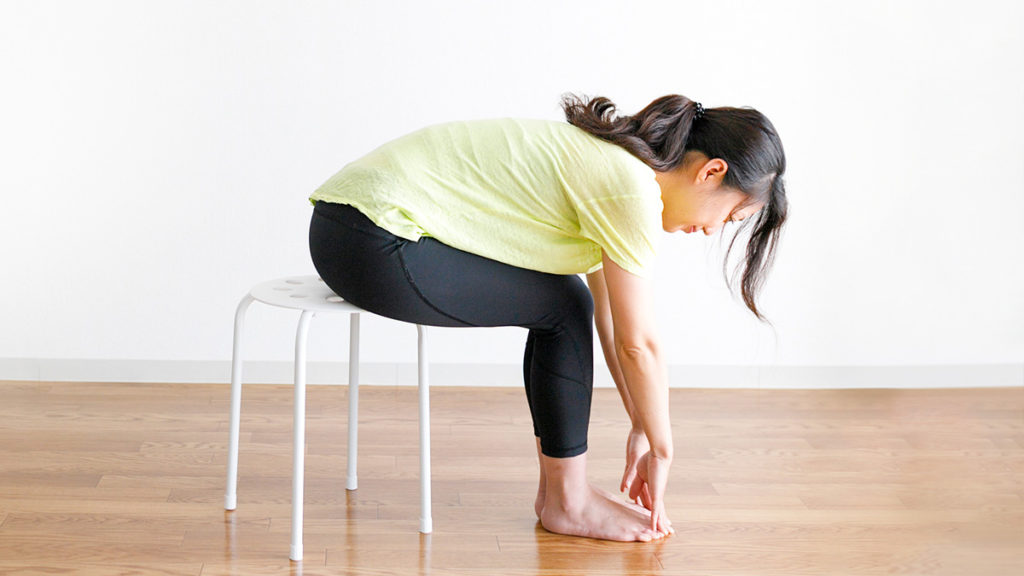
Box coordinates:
[0,382,1024,576]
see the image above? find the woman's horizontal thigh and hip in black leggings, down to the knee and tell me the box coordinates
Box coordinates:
[309,204,593,329]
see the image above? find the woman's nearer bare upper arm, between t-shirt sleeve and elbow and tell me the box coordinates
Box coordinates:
[588,253,657,351]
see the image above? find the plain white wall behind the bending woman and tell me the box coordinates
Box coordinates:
[0,0,1024,385]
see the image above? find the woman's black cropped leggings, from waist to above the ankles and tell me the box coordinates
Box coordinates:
[309,202,594,458]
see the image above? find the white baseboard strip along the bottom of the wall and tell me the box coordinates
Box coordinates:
[0,359,1024,388]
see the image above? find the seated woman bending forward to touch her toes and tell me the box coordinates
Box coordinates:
[309,95,786,541]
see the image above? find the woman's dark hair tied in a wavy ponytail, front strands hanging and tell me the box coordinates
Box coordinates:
[562,94,788,321]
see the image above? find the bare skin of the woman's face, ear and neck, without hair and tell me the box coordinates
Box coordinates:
[657,153,763,236]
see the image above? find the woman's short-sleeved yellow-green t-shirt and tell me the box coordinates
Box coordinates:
[309,119,662,276]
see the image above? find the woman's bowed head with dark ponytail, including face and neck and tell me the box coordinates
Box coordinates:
[562,94,788,320]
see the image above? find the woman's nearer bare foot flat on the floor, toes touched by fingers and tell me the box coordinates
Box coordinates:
[541,485,664,542]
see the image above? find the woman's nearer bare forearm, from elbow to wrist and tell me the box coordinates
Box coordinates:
[615,342,674,460]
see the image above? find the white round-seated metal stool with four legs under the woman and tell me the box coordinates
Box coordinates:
[224,276,433,561]
